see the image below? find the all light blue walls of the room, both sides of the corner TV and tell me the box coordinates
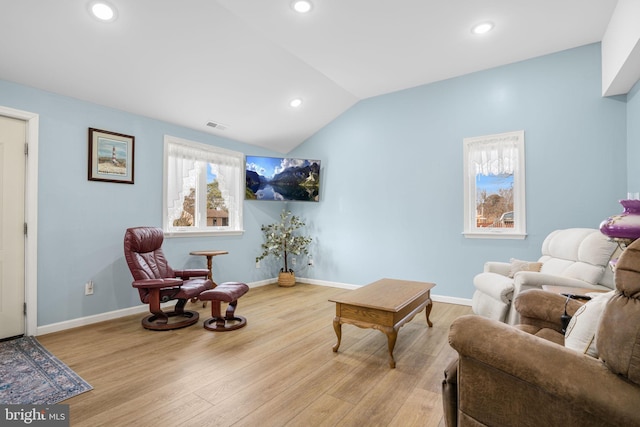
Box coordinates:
[0,41,640,325]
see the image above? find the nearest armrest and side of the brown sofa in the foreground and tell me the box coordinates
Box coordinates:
[449,315,640,426]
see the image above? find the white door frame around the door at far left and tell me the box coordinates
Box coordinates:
[0,105,40,336]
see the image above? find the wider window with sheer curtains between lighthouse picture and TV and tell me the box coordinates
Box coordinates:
[163,135,244,236]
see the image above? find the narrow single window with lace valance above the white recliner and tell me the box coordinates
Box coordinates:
[464,131,527,239]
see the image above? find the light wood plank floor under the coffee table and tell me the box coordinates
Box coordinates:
[37,284,471,427]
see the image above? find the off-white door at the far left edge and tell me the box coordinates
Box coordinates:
[0,116,26,339]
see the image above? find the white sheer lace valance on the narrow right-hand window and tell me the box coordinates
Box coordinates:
[468,135,519,177]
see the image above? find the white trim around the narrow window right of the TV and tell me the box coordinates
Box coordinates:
[462,130,527,239]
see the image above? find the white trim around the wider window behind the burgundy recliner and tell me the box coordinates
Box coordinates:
[162,135,245,237]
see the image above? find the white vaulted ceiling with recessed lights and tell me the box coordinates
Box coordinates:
[0,0,616,153]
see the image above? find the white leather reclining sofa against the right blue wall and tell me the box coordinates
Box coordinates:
[472,228,618,325]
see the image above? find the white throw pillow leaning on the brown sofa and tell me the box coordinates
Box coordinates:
[564,291,614,357]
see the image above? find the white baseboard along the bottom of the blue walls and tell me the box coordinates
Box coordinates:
[36,277,471,335]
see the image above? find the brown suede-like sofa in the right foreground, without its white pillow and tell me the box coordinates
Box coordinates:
[443,240,640,427]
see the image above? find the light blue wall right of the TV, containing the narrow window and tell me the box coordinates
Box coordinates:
[292,44,628,298]
